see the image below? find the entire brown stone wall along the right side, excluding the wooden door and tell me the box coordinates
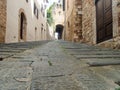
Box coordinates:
[66,0,120,49]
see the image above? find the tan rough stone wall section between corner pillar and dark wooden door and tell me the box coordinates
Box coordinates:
[82,0,95,44]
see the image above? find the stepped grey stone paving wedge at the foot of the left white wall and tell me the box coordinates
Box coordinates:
[0,41,48,60]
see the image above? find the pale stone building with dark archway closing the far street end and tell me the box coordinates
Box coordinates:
[53,0,64,39]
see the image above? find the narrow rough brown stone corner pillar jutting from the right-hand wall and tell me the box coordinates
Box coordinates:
[73,0,83,42]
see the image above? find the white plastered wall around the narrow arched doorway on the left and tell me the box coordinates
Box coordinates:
[5,0,46,43]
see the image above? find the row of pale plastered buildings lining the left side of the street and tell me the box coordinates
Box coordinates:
[0,0,48,43]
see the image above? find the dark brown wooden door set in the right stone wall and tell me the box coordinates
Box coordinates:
[96,0,113,43]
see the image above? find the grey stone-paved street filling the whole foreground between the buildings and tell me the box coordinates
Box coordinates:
[0,40,120,90]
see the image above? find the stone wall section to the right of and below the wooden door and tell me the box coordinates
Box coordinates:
[98,0,120,49]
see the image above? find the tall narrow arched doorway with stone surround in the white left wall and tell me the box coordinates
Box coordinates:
[18,9,27,42]
